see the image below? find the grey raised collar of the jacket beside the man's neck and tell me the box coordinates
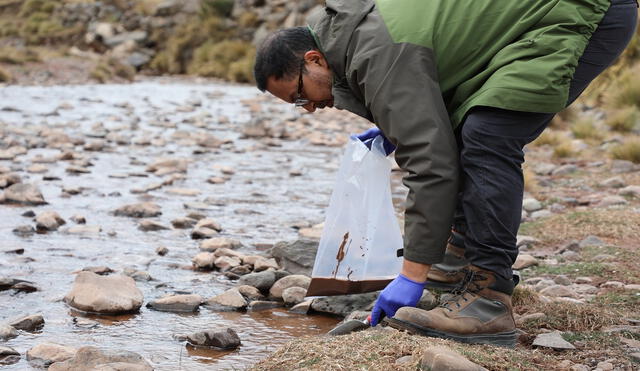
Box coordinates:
[308,0,375,77]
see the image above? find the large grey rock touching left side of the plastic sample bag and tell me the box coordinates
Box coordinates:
[269,240,318,276]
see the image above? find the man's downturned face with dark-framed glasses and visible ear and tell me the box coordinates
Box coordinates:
[267,50,333,112]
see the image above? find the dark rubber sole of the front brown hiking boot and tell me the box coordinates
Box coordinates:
[382,318,517,348]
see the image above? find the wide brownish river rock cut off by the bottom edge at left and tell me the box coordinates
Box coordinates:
[49,346,153,371]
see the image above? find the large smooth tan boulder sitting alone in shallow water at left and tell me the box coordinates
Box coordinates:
[64,272,144,314]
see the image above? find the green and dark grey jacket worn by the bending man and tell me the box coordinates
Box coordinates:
[309,0,609,264]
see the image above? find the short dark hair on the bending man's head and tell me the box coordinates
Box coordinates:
[253,27,318,92]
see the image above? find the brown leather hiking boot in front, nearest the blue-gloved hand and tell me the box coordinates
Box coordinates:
[383,266,516,347]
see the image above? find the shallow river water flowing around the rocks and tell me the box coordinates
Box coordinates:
[0,80,402,370]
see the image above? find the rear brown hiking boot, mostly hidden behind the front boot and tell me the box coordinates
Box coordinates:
[425,230,469,291]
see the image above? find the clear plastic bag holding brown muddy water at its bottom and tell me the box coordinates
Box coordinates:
[307,136,402,296]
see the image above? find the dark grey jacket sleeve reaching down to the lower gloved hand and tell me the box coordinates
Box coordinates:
[346,24,459,264]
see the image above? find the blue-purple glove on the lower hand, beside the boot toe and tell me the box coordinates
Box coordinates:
[371,274,426,326]
